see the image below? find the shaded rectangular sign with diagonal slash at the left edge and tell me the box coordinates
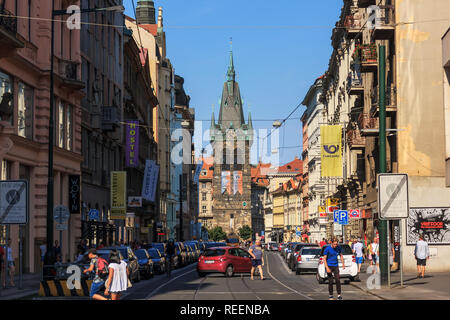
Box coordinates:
[0,180,29,224]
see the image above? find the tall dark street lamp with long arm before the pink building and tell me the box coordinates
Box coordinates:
[45,0,125,265]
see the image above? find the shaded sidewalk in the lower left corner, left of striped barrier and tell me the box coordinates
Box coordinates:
[0,273,41,300]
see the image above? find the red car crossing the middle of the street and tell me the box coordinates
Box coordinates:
[197,247,252,277]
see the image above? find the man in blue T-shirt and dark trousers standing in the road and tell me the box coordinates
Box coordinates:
[323,239,345,300]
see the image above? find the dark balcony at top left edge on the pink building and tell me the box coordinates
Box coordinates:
[0,9,25,56]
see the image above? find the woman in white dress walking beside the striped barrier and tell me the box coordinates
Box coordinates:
[105,250,128,300]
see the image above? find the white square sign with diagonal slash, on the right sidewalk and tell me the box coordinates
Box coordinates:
[378,173,409,220]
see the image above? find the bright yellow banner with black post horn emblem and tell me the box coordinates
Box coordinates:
[320,125,342,177]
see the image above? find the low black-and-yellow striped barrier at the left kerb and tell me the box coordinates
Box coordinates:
[39,280,93,297]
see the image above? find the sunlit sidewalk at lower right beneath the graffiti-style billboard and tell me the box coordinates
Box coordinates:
[350,264,450,300]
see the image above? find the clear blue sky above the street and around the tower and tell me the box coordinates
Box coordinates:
[124,0,342,168]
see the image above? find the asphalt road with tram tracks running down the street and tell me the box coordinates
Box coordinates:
[123,252,378,301]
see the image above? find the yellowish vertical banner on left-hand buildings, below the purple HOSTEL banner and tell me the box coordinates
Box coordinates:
[110,171,127,220]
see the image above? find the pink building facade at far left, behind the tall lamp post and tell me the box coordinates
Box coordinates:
[0,0,83,272]
